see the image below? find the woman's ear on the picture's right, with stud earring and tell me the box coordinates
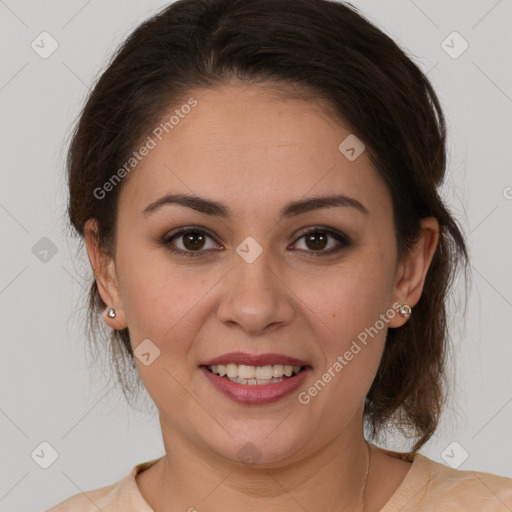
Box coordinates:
[388,217,439,327]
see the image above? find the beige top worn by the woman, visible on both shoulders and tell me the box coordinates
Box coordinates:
[45,448,512,512]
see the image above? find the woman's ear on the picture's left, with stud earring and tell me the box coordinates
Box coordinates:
[84,218,127,330]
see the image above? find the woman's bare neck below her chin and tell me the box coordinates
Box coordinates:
[138,416,369,512]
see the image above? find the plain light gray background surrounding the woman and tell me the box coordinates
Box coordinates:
[0,0,512,512]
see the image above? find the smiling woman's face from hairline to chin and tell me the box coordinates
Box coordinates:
[87,85,432,465]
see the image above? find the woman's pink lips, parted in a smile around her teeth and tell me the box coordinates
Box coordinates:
[200,352,311,404]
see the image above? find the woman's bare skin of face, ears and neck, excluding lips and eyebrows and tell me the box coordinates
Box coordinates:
[86,83,439,512]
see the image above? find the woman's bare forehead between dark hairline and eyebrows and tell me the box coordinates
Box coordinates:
[120,85,390,220]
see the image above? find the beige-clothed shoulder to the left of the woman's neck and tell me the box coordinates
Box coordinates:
[44,459,159,512]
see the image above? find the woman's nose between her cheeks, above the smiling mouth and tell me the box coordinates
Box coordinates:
[217,245,295,336]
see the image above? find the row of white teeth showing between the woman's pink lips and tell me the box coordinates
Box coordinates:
[208,363,302,384]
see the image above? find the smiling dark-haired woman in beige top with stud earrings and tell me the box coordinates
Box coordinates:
[46,0,512,512]
